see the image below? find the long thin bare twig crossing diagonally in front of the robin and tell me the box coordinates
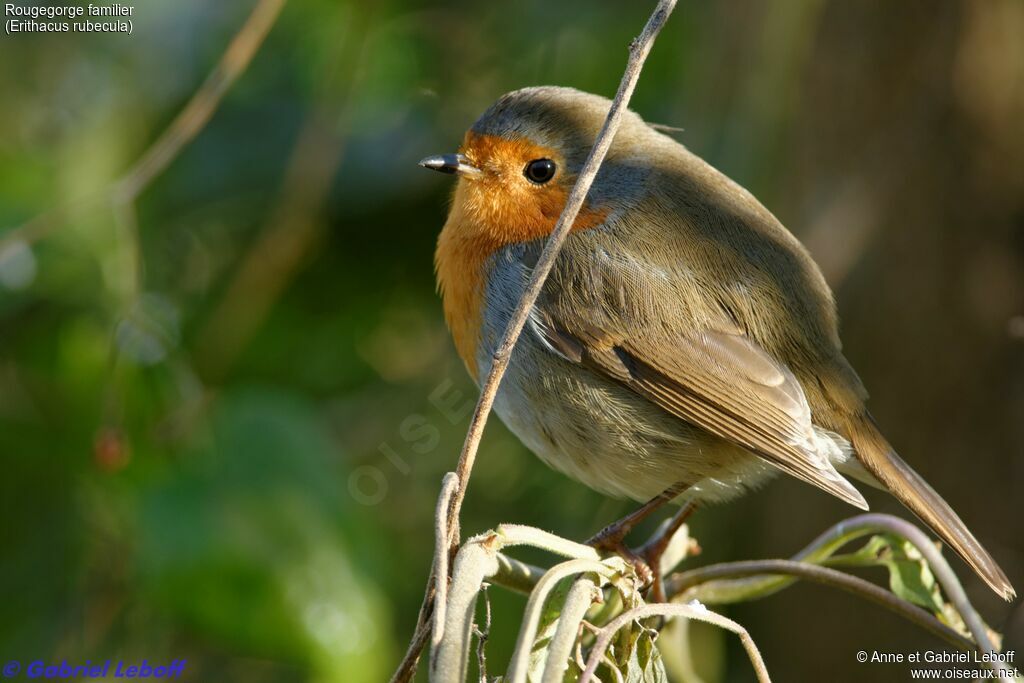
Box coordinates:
[392,0,676,681]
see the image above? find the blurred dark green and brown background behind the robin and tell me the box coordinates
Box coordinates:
[0,0,1024,681]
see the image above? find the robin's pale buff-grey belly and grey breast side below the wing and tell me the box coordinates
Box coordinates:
[477,248,777,502]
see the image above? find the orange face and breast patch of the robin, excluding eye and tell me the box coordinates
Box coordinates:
[435,131,608,378]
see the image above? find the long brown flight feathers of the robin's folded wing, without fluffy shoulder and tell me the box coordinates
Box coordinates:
[532,299,867,509]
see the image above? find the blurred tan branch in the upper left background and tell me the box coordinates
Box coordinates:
[0,0,286,252]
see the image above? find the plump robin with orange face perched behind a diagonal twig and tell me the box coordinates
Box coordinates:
[420,86,1016,600]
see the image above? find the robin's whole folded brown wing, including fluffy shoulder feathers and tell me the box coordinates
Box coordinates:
[530,237,867,509]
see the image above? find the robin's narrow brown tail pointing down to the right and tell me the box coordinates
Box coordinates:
[848,413,1017,601]
